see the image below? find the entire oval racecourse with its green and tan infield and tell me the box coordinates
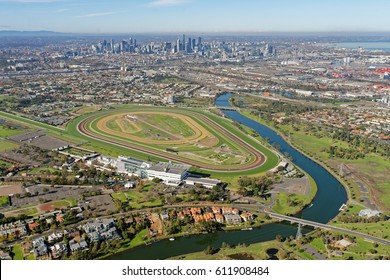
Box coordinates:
[77,107,277,171]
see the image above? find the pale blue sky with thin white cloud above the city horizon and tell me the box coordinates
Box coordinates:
[0,0,390,34]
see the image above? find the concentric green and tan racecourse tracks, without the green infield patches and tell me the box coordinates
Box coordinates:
[77,107,277,172]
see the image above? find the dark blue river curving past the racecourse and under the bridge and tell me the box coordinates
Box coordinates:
[108,93,347,260]
